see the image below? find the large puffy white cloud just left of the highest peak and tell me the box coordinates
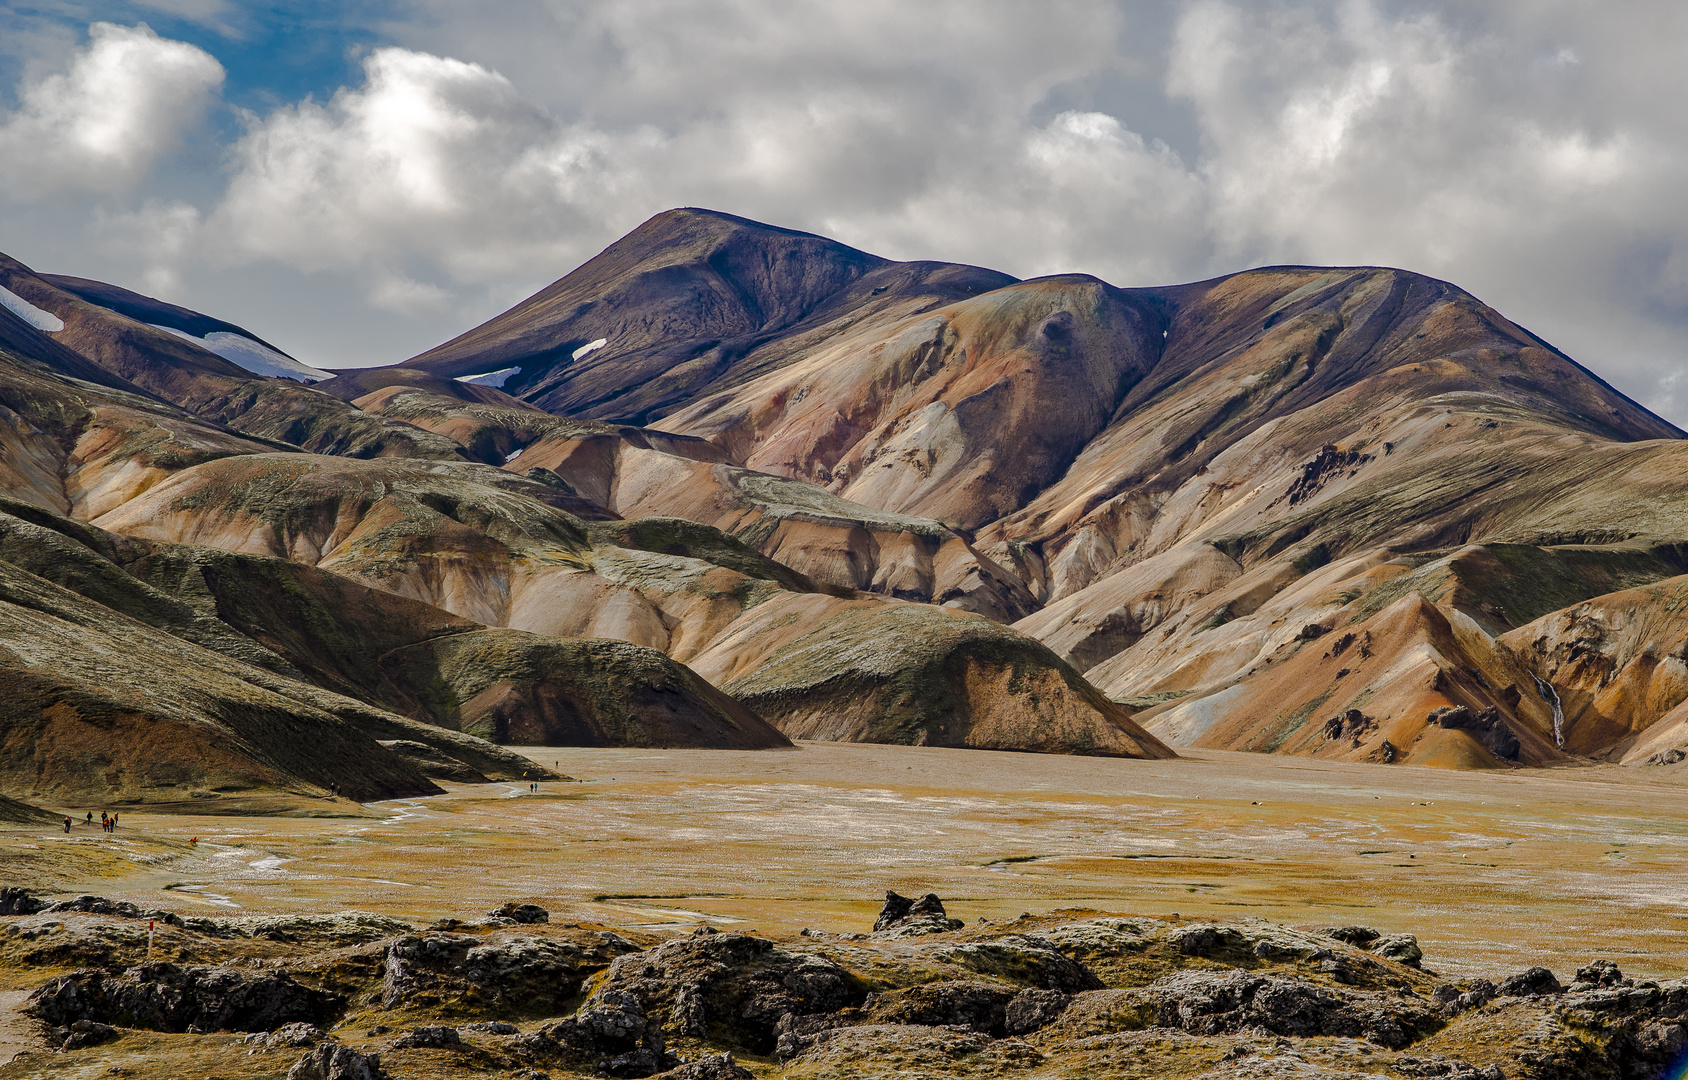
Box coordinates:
[208,47,638,295]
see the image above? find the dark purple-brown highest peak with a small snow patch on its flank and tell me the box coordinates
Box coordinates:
[407,209,1013,424]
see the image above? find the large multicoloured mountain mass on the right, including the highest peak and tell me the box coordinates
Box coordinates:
[376,209,1688,766]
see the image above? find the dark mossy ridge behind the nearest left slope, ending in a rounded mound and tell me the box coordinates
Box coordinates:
[0,492,787,802]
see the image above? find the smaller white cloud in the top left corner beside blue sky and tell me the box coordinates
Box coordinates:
[0,22,223,194]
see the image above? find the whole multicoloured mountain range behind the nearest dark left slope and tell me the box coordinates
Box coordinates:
[0,209,1688,793]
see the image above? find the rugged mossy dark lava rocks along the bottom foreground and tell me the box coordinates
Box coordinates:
[0,888,1688,1080]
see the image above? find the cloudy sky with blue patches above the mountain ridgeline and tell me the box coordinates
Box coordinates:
[0,0,1688,427]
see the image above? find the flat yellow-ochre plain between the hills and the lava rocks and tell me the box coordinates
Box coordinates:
[0,743,1688,977]
